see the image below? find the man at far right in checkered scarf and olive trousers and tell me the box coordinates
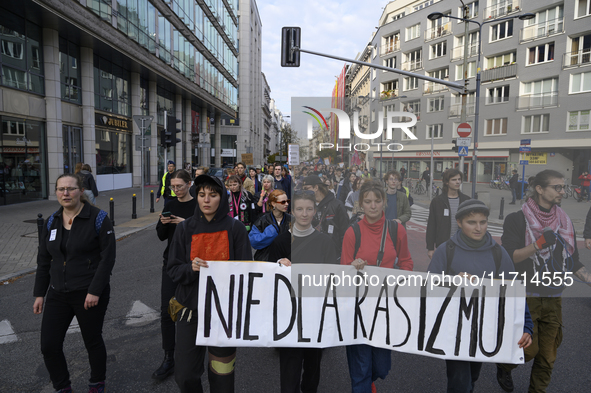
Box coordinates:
[497,169,591,393]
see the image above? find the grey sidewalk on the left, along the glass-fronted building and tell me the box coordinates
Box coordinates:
[0,186,164,282]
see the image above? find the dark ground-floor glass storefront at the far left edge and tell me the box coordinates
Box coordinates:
[0,116,47,205]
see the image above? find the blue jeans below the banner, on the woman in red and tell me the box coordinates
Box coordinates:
[346,344,392,393]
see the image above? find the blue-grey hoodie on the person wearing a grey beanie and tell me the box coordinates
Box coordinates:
[427,229,534,336]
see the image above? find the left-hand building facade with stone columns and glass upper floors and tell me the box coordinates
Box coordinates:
[0,0,238,204]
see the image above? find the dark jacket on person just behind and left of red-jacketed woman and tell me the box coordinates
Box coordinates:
[312,192,349,255]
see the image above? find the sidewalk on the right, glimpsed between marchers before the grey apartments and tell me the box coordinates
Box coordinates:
[411,181,591,237]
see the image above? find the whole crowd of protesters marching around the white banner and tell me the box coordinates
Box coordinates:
[34,161,591,393]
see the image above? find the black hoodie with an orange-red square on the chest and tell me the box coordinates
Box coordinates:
[167,178,252,310]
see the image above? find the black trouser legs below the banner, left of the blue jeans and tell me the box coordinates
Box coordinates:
[279,348,322,393]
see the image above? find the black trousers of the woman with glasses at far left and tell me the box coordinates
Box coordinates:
[41,285,110,390]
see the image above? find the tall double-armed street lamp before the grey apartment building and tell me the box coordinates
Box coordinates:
[427,12,536,198]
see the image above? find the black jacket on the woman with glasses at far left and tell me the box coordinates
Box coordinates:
[33,203,115,297]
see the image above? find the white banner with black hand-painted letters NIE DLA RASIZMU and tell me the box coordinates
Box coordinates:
[196,261,525,363]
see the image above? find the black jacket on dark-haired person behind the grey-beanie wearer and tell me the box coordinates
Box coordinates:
[426,192,470,250]
